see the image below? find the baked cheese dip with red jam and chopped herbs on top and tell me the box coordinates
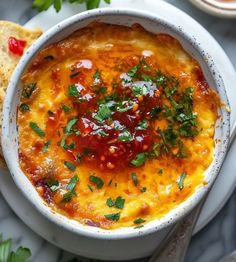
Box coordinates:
[18,23,220,229]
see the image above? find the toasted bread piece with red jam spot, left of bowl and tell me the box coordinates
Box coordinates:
[0,21,42,167]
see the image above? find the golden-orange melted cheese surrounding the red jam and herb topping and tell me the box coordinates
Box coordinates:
[18,24,218,229]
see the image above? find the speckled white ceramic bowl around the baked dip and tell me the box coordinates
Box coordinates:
[2,9,230,259]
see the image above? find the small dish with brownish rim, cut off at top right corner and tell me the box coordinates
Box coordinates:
[190,0,236,18]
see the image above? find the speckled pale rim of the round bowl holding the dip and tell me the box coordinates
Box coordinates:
[2,8,230,239]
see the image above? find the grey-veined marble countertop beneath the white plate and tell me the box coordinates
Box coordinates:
[0,0,236,262]
